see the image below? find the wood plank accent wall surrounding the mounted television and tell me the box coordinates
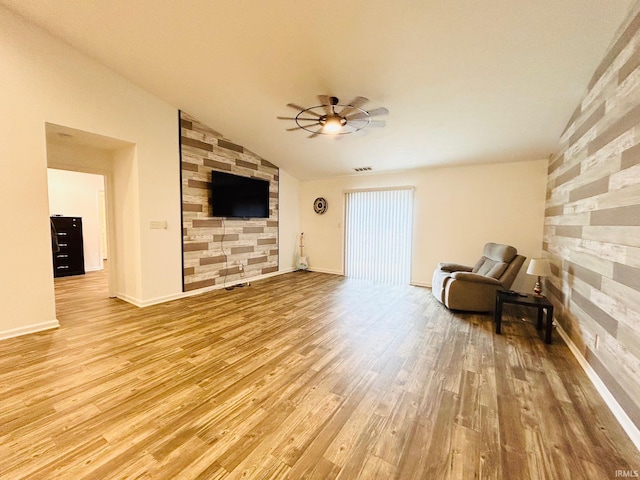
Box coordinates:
[180,112,279,291]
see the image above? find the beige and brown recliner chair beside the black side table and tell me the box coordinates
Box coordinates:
[431,243,526,312]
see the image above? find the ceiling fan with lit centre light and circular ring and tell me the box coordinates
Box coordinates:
[278,95,389,138]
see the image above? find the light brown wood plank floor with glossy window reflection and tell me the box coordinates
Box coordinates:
[0,272,640,480]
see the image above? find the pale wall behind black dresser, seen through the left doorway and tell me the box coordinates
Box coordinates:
[47,168,104,272]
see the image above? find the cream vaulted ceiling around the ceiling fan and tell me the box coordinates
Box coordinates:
[0,0,634,180]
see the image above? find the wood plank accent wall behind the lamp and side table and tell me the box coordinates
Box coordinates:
[544,8,640,434]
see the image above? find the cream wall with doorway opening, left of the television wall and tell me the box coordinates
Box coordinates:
[0,3,182,337]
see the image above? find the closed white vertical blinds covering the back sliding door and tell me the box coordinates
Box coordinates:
[345,188,413,284]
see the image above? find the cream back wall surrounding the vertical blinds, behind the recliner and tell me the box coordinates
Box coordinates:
[300,160,547,289]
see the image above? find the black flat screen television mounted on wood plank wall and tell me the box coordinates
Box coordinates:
[211,170,269,218]
